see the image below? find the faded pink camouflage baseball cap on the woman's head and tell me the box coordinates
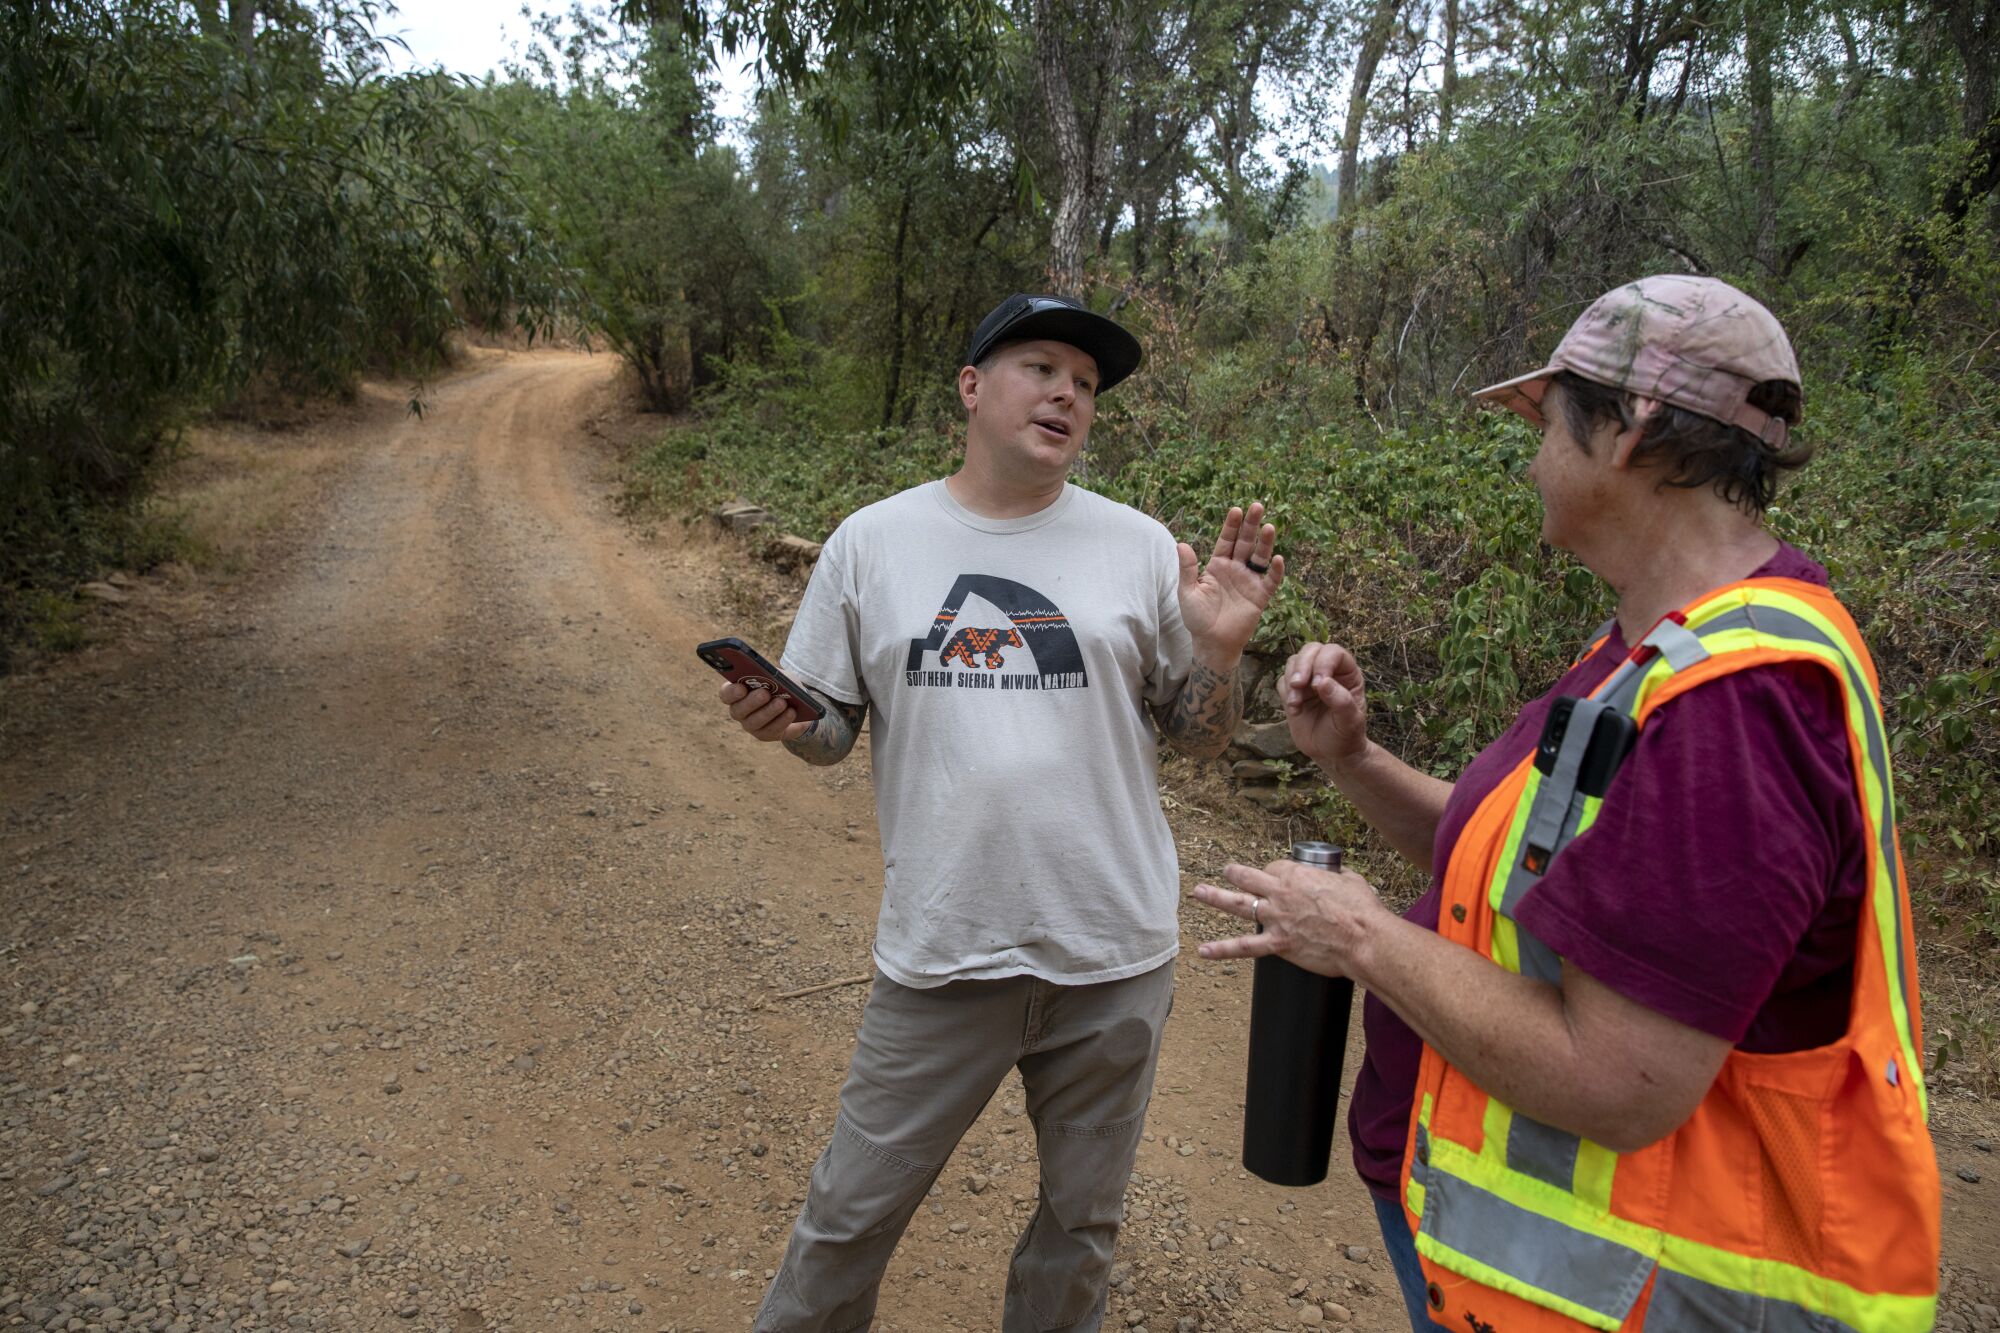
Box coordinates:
[1472,274,1802,450]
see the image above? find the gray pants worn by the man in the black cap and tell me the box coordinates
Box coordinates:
[754,963,1174,1333]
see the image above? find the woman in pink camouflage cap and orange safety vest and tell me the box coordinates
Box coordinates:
[1196,276,1938,1333]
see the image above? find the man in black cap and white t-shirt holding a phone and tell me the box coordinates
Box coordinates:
[722,294,1284,1333]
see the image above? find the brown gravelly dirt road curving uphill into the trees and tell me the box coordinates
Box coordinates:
[0,352,1992,1333]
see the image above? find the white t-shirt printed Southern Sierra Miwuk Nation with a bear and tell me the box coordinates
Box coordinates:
[782,480,1194,987]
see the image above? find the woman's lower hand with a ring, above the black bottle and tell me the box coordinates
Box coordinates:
[1194,861,1394,979]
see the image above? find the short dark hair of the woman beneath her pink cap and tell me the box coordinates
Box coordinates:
[1550,370,1812,514]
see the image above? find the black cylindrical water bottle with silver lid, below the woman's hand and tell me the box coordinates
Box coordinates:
[1244,843,1354,1185]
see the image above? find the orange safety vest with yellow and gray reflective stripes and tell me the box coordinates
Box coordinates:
[1402,578,1940,1333]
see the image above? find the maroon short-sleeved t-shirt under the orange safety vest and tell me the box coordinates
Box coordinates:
[1348,546,1866,1201]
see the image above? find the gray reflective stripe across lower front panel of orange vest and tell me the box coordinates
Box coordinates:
[1410,1125,1654,1321]
